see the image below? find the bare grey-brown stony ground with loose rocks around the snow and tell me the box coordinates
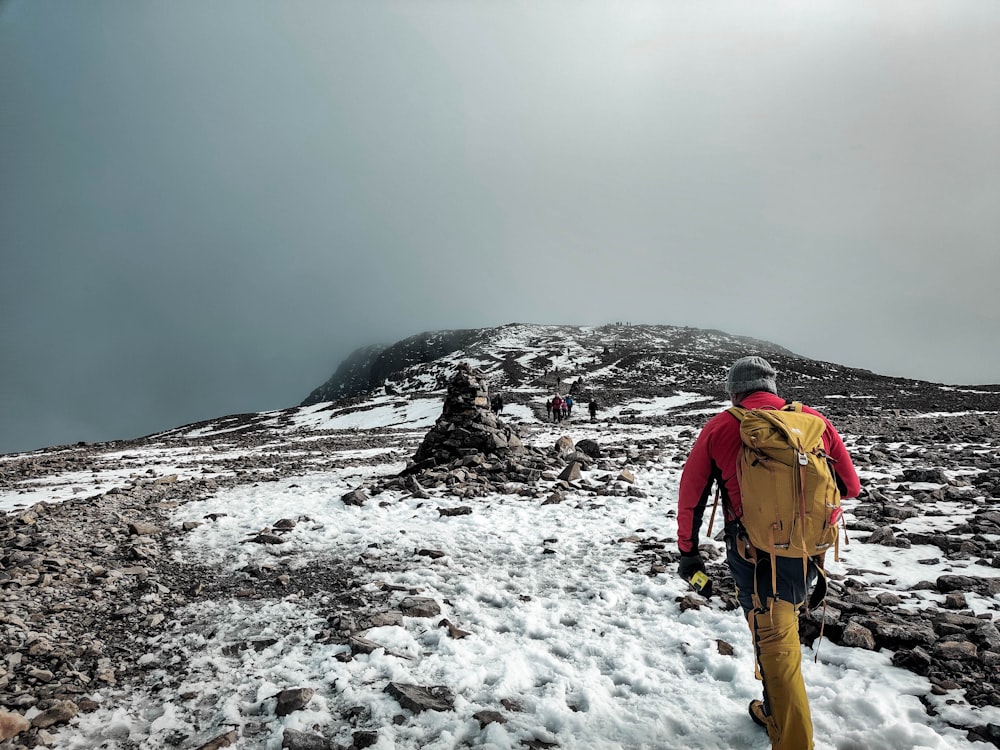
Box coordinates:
[0,368,1000,750]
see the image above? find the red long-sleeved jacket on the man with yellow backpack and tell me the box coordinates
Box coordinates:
[677,391,861,552]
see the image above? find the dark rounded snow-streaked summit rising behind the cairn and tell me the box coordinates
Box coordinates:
[300,323,1000,412]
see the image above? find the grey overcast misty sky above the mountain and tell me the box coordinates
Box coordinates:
[0,0,1000,451]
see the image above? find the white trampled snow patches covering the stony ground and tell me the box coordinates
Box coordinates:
[0,394,1000,750]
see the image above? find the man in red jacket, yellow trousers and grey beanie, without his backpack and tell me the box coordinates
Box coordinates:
[677,357,861,750]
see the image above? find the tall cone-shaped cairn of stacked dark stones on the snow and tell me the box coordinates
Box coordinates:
[414,363,524,466]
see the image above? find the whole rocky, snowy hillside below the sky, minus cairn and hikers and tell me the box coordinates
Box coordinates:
[0,325,1000,750]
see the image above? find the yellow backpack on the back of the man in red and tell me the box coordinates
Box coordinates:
[729,402,841,560]
